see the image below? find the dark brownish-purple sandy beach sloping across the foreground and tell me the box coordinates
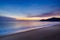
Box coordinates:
[0,25,60,40]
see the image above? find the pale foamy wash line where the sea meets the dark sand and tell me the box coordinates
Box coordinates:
[0,23,59,36]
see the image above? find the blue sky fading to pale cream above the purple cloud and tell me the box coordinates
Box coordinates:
[0,0,60,18]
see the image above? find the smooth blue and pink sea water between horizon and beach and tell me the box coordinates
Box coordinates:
[0,21,59,35]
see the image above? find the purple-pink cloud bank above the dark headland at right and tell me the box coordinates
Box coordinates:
[31,10,60,17]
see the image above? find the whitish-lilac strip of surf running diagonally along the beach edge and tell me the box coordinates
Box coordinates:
[0,22,59,36]
